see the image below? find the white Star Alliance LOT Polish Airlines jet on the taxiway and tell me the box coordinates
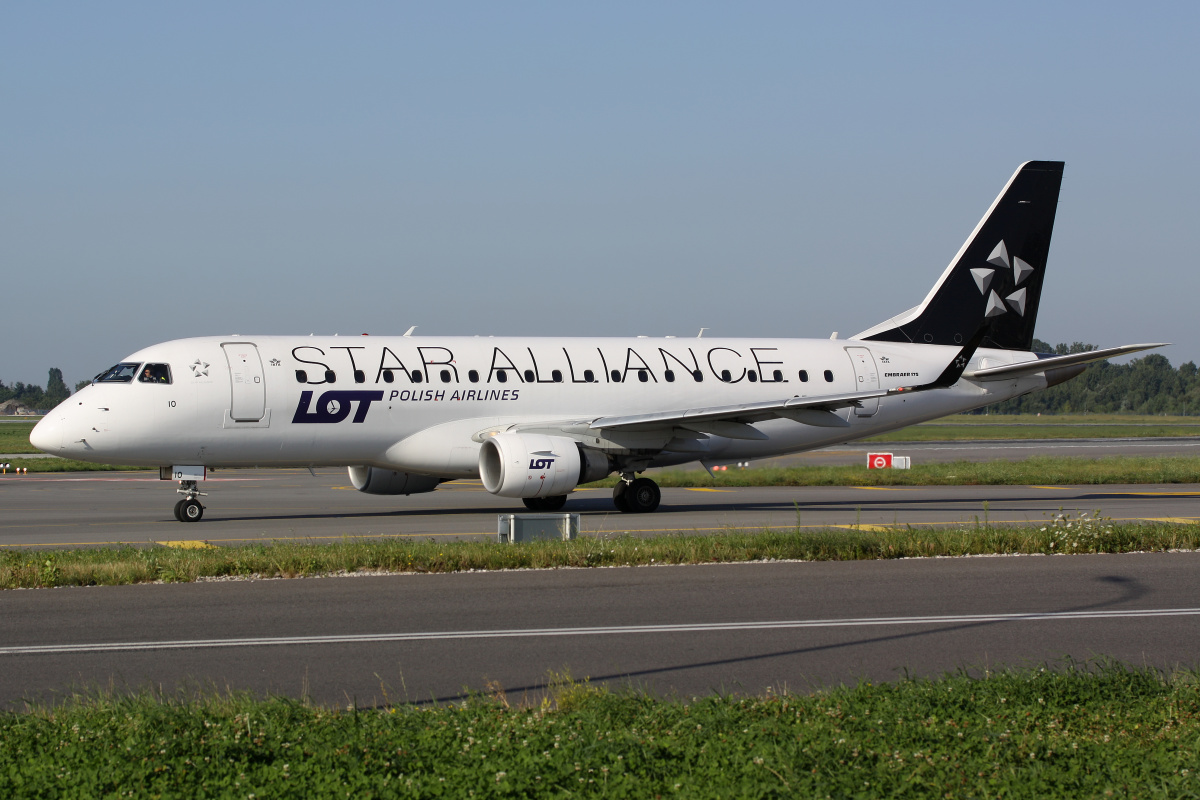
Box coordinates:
[30,161,1164,522]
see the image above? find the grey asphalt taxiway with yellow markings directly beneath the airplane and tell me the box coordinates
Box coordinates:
[0,470,1200,548]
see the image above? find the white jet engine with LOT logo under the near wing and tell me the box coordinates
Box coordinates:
[479,433,612,498]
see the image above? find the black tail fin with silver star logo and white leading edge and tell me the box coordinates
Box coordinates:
[854,161,1063,350]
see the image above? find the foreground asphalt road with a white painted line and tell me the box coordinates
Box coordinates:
[0,553,1200,708]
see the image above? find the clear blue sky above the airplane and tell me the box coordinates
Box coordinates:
[0,2,1200,385]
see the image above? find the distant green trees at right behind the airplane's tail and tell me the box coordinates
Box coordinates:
[974,339,1200,416]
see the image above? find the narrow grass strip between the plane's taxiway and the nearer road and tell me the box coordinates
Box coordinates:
[0,506,1200,589]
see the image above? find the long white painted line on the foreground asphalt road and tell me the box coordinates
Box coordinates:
[0,608,1200,656]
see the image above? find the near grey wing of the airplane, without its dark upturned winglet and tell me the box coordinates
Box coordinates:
[588,389,889,439]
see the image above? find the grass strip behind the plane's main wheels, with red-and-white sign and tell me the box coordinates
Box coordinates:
[628,456,1200,487]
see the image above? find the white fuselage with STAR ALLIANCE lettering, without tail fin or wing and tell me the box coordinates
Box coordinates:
[31,336,1045,479]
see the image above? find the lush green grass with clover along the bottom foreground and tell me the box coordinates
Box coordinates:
[0,662,1200,798]
